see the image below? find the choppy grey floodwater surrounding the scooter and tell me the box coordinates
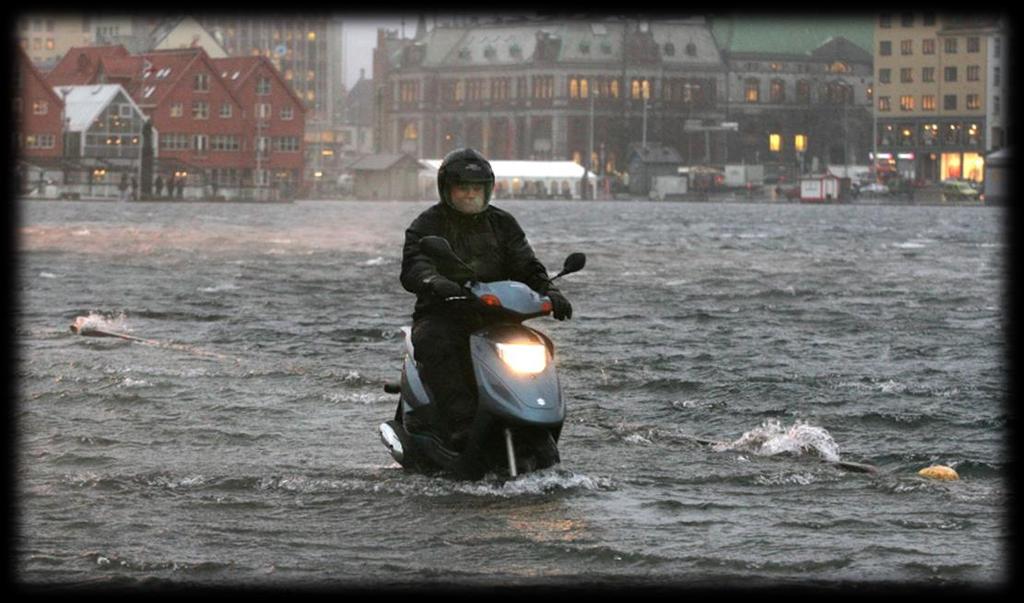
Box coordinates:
[11,202,1011,588]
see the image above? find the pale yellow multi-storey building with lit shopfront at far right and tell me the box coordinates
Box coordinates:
[874,12,1008,182]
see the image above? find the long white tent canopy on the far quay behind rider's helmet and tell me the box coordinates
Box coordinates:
[420,159,597,199]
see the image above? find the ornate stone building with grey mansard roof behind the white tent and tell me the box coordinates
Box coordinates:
[374,18,725,177]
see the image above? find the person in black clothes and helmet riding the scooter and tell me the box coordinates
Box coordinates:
[401,148,572,451]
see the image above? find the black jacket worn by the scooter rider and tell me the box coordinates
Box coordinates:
[401,203,557,320]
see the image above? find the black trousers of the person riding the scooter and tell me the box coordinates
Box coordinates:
[413,312,483,438]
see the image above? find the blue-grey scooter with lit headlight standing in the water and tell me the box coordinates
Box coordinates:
[378,236,587,480]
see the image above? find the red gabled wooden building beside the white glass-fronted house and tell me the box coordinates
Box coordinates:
[47,46,305,200]
